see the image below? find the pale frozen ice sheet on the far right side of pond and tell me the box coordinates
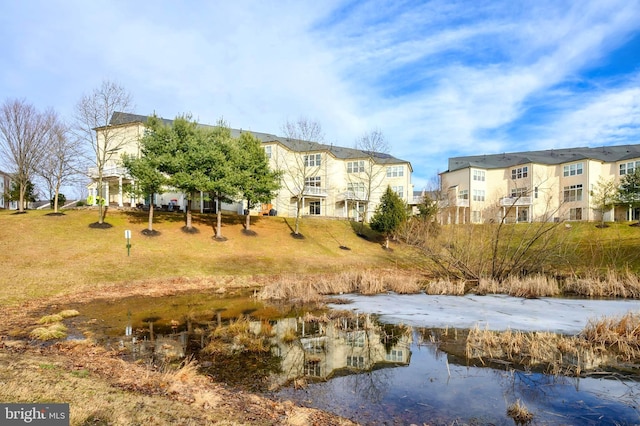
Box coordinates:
[333,294,640,334]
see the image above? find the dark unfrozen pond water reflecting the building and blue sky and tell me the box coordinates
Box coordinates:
[74,294,640,425]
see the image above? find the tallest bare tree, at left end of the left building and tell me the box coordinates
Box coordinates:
[74,80,132,225]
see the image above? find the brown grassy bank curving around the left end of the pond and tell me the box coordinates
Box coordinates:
[0,277,352,425]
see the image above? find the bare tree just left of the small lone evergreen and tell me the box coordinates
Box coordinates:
[347,129,389,226]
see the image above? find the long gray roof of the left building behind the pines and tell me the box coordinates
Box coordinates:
[109,112,411,166]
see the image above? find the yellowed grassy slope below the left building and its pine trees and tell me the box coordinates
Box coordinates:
[0,209,419,305]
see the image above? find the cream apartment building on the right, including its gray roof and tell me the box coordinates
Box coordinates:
[440,145,640,223]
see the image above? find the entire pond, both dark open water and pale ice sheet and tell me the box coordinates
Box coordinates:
[66,294,640,425]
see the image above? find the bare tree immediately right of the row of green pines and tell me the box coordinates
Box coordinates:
[277,117,326,236]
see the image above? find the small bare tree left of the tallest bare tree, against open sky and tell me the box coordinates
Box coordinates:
[38,120,83,213]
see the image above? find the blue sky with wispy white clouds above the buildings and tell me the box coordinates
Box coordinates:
[0,0,640,189]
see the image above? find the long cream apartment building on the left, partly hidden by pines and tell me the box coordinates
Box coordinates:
[89,113,413,220]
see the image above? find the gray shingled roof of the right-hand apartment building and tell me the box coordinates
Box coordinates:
[448,145,640,172]
